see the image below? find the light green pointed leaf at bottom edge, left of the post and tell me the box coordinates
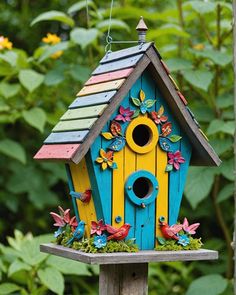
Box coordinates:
[38,267,64,295]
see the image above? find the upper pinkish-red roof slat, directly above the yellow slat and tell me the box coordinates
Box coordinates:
[85,68,133,86]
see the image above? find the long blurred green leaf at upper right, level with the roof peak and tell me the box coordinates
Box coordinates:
[190,49,233,66]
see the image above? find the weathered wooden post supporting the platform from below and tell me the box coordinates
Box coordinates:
[99,263,148,295]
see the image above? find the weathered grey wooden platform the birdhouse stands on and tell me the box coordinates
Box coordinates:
[40,244,218,264]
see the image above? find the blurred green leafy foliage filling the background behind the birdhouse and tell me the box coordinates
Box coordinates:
[0,0,235,295]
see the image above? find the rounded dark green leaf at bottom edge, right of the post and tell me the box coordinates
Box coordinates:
[186,274,227,295]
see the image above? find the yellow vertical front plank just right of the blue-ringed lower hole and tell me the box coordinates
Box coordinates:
[156,145,168,236]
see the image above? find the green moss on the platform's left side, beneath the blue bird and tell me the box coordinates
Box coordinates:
[56,233,139,253]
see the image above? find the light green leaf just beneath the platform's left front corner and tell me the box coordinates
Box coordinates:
[46,256,91,276]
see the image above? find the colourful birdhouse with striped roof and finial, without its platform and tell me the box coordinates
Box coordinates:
[34,20,220,250]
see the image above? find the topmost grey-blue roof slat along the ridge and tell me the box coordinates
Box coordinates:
[100,42,153,64]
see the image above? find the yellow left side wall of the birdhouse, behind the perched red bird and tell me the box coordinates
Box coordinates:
[70,158,97,237]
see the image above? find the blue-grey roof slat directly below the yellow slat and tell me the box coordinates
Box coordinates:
[69,90,117,109]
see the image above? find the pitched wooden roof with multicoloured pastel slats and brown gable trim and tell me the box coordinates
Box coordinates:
[34,43,221,166]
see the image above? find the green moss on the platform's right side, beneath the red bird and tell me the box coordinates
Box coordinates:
[155,237,203,251]
